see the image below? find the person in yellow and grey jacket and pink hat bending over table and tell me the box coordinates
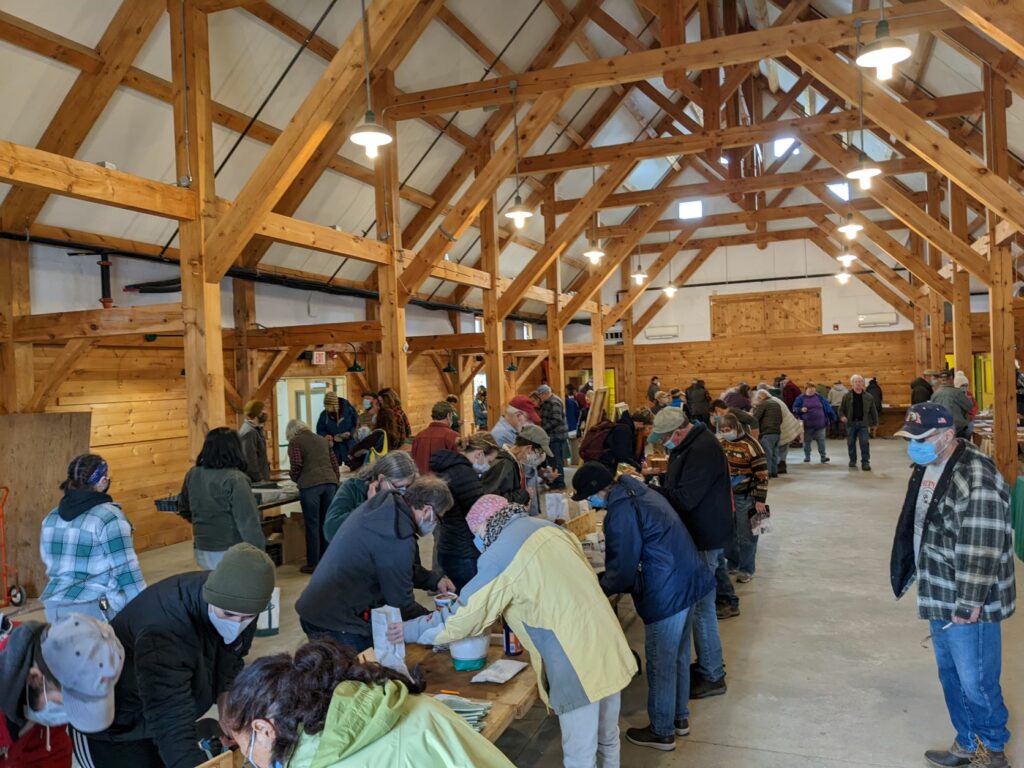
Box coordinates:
[403,495,637,768]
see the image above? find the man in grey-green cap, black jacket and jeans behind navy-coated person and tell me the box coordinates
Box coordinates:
[651,408,735,704]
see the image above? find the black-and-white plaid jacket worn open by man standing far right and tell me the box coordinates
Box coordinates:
[892,440,1017,622]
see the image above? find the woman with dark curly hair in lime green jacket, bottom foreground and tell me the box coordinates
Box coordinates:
[221,639,512,768]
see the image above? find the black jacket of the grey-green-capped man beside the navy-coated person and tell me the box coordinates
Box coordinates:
[662,423,735,552]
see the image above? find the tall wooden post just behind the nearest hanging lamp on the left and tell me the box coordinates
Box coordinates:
[374,70,409,401]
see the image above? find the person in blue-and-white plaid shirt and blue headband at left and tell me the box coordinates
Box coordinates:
[39,454,145,624]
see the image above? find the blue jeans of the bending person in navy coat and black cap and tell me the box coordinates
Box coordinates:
[643,608,690,736]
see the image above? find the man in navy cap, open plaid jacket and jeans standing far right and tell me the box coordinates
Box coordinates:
[890,402,1017,768]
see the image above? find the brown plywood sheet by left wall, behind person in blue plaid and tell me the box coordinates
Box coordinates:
[0,413,89,596]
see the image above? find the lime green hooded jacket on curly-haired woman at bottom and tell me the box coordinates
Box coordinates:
[286,681,512,768]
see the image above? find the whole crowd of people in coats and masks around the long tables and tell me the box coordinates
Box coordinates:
[0,371,1015,768]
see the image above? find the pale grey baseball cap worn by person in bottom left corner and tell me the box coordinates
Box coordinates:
[40,613,125,733]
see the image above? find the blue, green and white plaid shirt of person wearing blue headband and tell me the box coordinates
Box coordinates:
[39,503,145,618]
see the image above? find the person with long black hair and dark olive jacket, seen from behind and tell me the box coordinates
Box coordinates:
[178,427,266,570]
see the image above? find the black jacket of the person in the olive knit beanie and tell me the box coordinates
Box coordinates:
[90,570,256,768]
